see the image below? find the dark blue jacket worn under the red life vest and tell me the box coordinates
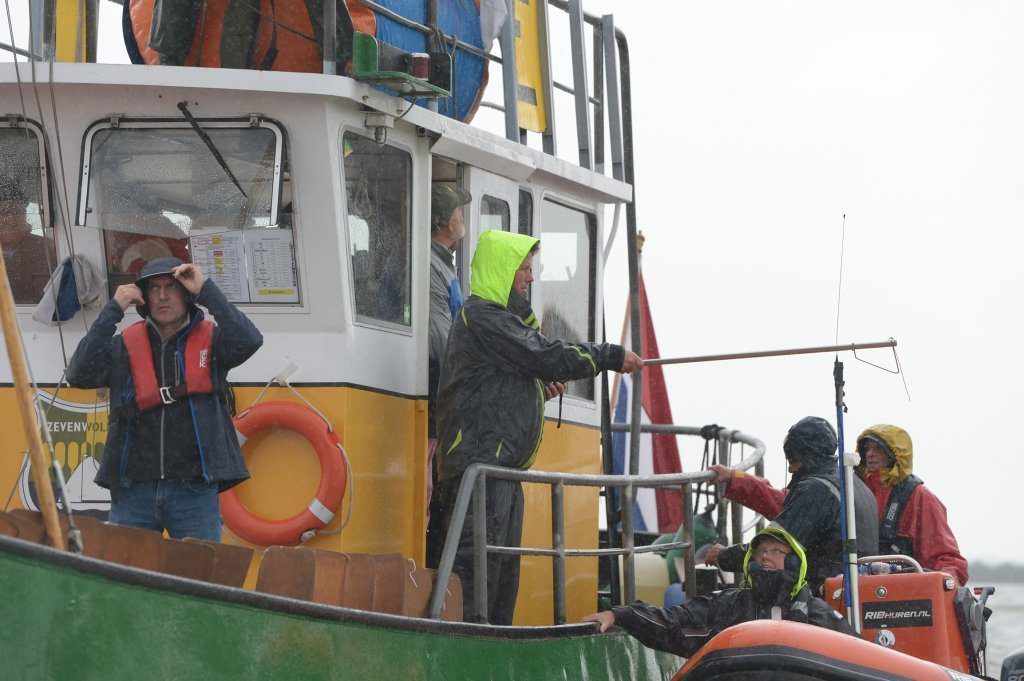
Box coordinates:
[68,280,263,492]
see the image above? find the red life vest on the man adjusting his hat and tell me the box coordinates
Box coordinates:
[121,320,216,412]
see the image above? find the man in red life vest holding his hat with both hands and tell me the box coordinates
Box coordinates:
[67,258,263,541]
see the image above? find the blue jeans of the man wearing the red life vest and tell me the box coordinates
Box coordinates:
[110,480,221,542]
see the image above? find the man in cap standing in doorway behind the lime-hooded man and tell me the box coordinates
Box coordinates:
[427,184,473,567]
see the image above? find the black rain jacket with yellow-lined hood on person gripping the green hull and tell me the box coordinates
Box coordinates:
[612,528,857,657]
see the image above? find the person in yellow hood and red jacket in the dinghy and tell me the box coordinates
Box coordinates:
[854,423,968,585]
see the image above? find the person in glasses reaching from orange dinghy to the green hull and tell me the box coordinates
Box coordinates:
[583,527,857,657]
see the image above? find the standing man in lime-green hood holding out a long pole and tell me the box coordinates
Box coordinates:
[436,230,643,625]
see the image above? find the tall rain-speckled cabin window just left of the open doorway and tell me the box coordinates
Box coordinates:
[342,132,413,327]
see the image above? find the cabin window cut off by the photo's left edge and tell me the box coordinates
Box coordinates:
[0,122,57,305]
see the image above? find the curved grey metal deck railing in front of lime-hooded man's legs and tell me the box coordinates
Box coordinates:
[427,424,765,624]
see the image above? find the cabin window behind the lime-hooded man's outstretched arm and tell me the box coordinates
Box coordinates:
[532,200,597,399]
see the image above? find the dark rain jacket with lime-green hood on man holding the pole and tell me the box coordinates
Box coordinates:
[437,230,625,480]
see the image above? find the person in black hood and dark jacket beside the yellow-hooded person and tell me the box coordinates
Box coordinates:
[707,416,879,594]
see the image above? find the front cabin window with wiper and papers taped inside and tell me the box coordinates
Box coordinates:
[78,119,299,303]
